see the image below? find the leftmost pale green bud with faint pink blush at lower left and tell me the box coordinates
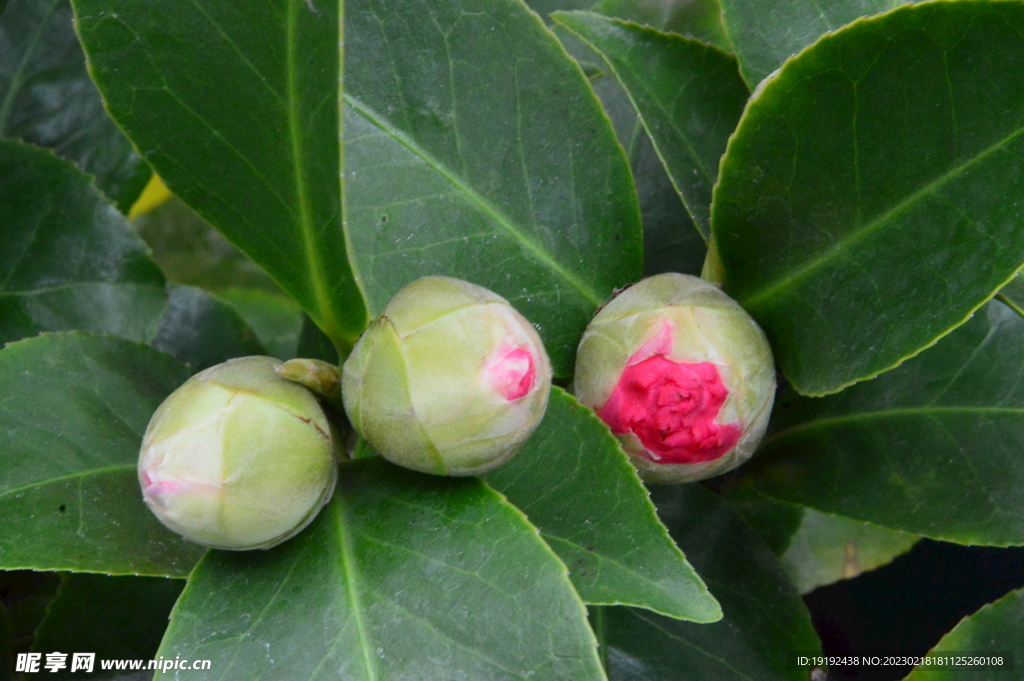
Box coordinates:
[138,356,337,550]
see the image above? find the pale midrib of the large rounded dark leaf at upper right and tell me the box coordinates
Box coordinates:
[741,118,1024,309]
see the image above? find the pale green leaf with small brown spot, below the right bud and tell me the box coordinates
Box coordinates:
[779,508,921,594]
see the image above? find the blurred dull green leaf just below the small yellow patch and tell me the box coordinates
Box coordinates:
[132,197,283,295]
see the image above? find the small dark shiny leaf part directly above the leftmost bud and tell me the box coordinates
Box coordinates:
[153,284,266,371]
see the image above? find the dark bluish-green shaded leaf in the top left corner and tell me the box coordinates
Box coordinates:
[0,0,151,213]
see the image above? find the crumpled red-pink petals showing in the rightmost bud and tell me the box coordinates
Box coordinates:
[597,333,742,464]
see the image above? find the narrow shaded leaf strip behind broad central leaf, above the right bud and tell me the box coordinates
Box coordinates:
[554,25,708,276]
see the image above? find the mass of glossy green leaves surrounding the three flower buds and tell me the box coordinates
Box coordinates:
[0,0,1024,681]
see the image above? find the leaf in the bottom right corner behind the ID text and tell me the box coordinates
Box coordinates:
[906,589,1024,681]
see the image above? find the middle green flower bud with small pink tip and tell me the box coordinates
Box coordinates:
[341,276,551,475]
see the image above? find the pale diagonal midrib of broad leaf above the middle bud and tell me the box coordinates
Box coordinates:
[343,92,606,305]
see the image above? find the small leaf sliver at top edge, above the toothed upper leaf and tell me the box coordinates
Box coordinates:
[589,0,732,52]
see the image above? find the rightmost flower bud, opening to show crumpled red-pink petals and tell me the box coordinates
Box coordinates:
[575,273,775,482]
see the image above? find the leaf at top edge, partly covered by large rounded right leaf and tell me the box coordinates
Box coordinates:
[719,0,908,88]
